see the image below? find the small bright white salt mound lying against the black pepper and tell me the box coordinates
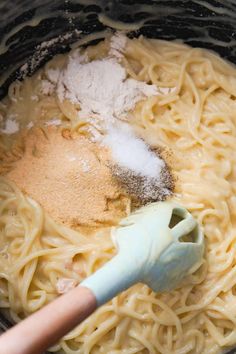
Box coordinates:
[103,124,164,178]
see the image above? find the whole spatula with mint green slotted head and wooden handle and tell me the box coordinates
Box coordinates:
[0,202,204,354]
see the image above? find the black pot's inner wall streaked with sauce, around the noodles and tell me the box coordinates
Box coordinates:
[0,0,236,354]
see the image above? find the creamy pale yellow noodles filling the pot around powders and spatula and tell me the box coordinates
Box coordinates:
[0,38,236,354]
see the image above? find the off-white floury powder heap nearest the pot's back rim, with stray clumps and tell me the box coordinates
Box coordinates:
[42,32,175,123]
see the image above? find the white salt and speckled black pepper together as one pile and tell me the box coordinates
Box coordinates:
[103,124,173,204]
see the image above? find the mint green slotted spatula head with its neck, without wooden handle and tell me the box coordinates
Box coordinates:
[81,202,204,305]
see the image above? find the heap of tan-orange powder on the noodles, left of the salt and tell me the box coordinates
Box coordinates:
[7,127,127,226]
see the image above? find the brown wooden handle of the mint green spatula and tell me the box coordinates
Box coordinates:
[0,286,97,354]
